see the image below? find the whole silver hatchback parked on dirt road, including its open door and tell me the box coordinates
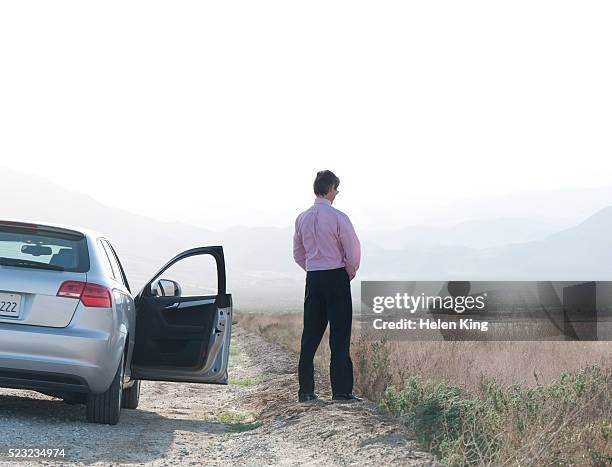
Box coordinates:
[0,221,232,425]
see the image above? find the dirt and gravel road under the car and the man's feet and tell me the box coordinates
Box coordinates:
[0,326,432,466]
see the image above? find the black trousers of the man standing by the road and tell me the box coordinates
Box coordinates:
[298,268,353,394]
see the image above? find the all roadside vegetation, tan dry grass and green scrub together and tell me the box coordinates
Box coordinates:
[240,314,612,466]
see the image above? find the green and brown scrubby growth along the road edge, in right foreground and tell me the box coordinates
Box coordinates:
[380,367,612,465]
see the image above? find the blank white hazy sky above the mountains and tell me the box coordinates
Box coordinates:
[0,0,612,227]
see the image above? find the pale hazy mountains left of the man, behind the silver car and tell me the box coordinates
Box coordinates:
[0,168,303,308]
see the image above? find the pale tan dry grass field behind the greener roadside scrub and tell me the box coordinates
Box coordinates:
[240,313,612,387]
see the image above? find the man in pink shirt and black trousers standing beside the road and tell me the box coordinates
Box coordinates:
[293,170,361,402]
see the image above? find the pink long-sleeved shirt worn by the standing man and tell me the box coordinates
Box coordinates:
[293,198,361,279]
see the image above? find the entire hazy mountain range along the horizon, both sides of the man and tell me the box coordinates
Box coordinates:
[0,169,612,309]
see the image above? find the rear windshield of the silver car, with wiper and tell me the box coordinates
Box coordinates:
[0,226,89,272]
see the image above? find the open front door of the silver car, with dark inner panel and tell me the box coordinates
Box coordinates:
[132,246,232,384]
